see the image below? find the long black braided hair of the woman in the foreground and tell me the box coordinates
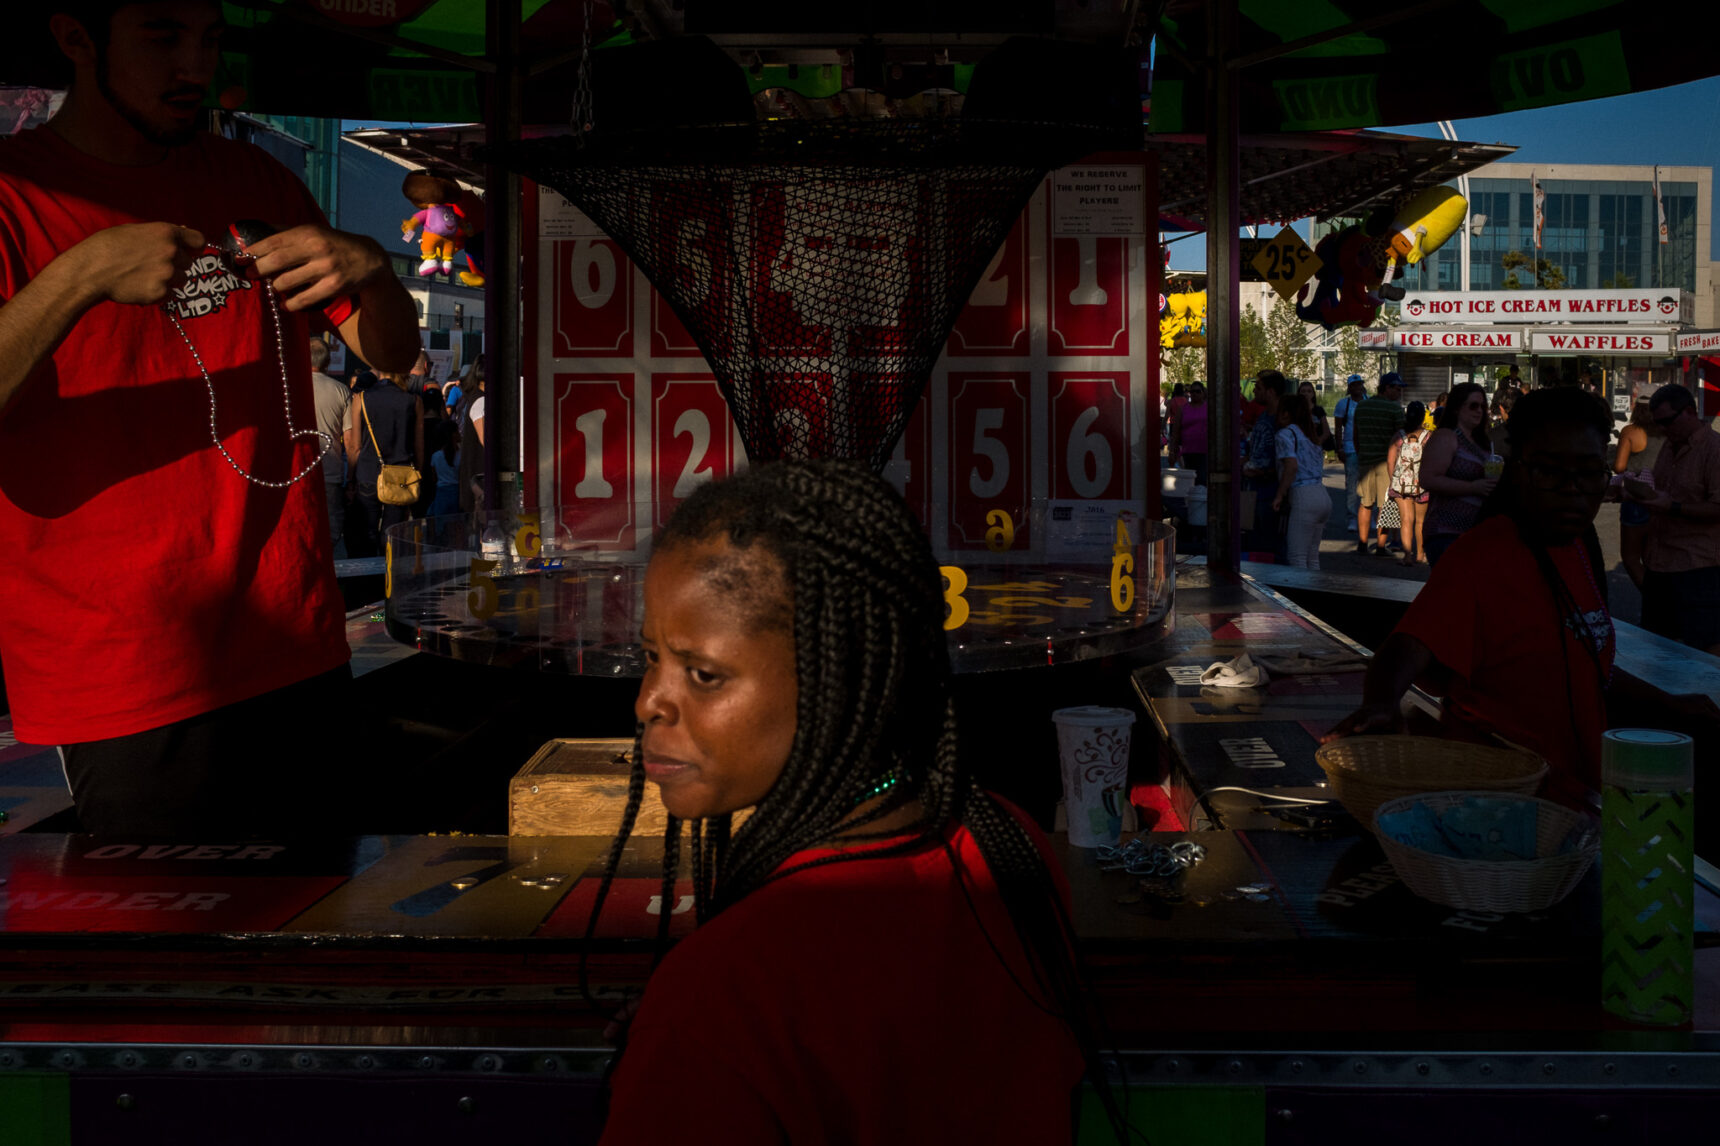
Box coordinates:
[581,461,1128,1137]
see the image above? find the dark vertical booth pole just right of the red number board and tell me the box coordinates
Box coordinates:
[1206,0,1242,573]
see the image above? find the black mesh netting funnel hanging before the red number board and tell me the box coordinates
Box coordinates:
[492,35,1140,470]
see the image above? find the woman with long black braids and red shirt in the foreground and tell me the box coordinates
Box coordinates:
[593,461,1116,1144]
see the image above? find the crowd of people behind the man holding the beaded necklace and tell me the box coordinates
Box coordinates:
[310,344,485,558]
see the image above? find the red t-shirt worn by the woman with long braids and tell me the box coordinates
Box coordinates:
[602,801,1084,1146]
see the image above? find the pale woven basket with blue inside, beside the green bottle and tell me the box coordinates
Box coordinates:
[1374,792,1601,912]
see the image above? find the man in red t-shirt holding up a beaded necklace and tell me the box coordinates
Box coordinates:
[0,0,418,836]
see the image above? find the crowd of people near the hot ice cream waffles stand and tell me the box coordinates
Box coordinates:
[1164,367,1720,650]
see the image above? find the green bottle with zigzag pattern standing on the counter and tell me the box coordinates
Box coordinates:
[1601,728,1696,1027]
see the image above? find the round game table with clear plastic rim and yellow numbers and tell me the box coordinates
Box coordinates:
[387,506,1176,676]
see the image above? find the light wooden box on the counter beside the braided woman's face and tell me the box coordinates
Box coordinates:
[507,738,666,836]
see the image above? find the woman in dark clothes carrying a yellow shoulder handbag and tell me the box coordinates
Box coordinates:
[346,373,425,558]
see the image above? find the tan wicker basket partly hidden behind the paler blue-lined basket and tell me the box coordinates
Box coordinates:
[1314,736,1546,831]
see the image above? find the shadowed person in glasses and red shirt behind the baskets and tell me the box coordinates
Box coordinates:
[1326,387,1613,804]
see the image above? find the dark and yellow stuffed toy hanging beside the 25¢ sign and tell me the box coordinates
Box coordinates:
[1295,188,1469,330]
